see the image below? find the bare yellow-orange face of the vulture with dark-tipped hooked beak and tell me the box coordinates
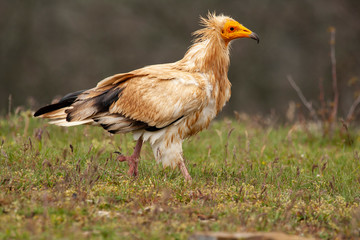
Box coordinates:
[221,20,259,42]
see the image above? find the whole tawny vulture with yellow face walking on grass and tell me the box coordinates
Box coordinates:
[34,13,259,181]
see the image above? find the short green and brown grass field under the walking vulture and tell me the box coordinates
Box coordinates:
[0,111,360,239]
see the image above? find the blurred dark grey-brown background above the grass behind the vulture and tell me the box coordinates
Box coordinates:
[0,0,360,119]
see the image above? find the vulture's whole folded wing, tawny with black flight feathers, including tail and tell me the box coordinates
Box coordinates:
[35,65,206,133]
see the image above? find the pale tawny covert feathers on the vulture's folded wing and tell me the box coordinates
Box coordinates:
[109,70,206,128]
